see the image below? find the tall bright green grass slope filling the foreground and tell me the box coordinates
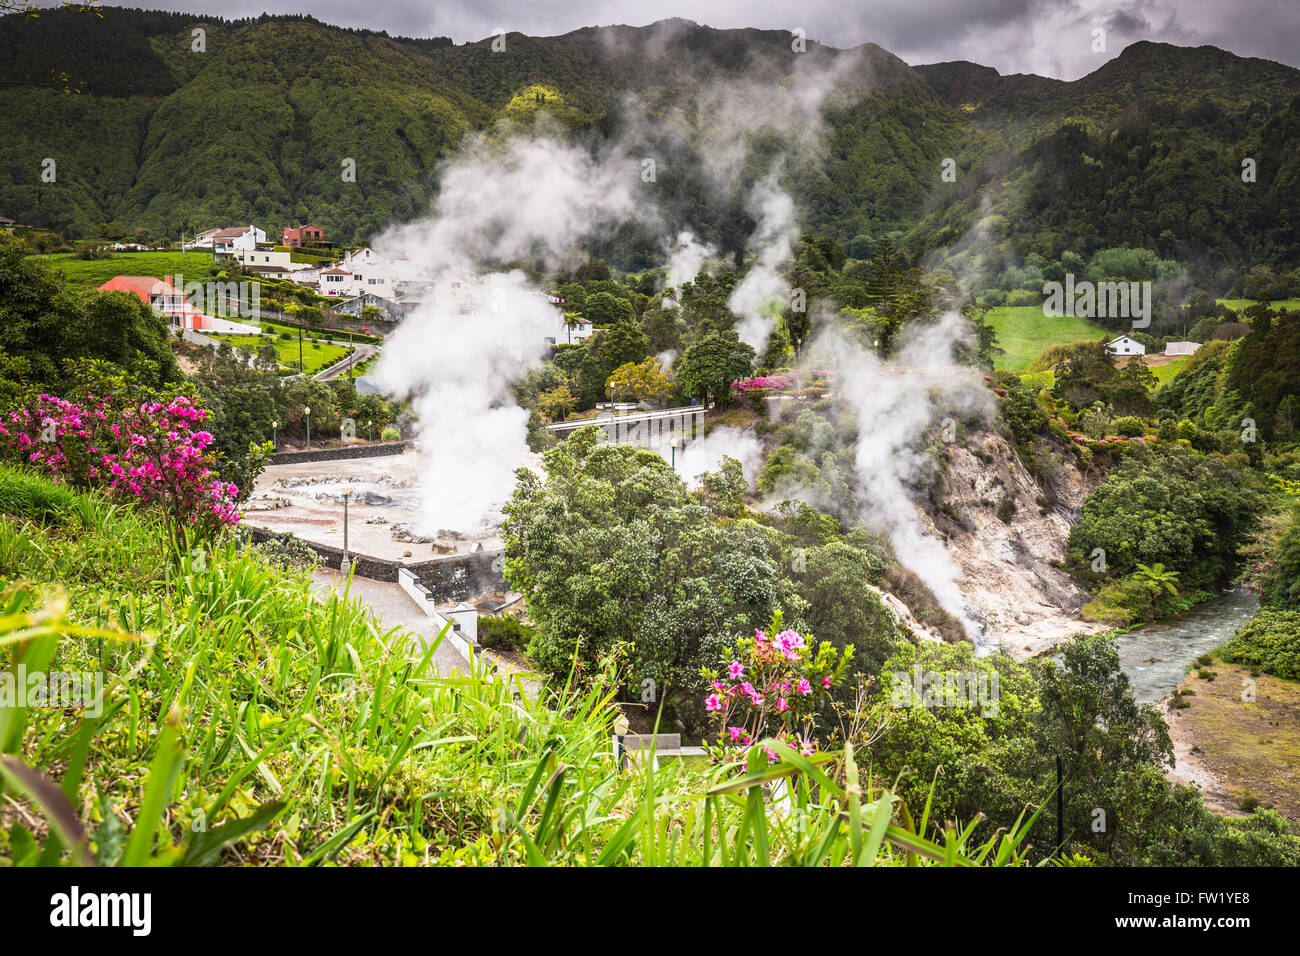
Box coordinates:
[0,468,1032,866]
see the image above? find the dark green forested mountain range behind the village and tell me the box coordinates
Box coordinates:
[0,8,1300,264]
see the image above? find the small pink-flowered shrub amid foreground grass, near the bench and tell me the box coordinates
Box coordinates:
[703,611,853,761]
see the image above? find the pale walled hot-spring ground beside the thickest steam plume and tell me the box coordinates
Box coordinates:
[243,451,502,563]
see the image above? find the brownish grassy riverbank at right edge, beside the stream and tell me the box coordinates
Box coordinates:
[1162,661,1300,823]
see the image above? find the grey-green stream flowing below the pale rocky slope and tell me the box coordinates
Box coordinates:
[1115,588,1258,702]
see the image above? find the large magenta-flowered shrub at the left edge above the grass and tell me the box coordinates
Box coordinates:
[0,394,239,536]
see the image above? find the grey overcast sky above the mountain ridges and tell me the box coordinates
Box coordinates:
[106,0,1300,79]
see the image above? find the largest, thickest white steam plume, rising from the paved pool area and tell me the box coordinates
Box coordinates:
[376,133,647,533]
